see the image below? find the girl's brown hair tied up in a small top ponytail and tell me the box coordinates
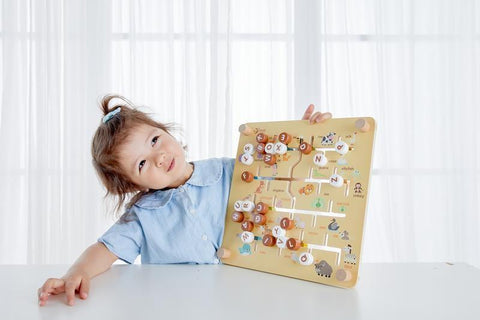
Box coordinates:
[91,95,180,217]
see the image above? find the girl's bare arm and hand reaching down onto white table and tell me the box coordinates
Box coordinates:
[38,242,118,306]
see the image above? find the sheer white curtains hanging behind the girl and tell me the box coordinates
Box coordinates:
[0,0,480,266]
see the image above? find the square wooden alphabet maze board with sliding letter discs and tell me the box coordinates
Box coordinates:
[219,118,375,287]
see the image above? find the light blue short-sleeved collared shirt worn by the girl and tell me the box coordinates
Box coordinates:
[98,158,235,264]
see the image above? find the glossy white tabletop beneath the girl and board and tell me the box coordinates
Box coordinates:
[0,263,480,320]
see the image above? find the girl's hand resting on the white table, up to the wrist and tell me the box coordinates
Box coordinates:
[38,273,90,306]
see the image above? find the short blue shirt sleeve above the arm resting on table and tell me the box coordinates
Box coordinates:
[98,212,143,264]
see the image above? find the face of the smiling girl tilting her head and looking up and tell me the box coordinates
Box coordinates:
[119,124,193,190]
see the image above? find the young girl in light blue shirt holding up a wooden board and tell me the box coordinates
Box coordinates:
[38,95,331,306]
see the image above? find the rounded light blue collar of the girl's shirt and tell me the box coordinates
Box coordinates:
[135,159,223,209]
